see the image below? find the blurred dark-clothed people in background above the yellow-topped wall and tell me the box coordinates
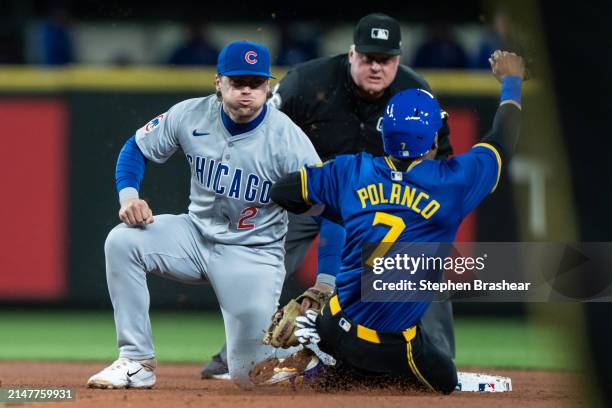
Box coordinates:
[0,8,512,69]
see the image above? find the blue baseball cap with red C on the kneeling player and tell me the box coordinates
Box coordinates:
[217,41,274,78]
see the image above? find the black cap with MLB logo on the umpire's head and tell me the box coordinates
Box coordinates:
[353,13,402,55]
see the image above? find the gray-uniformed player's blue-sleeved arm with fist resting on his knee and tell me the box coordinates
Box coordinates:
[115,137,153,225]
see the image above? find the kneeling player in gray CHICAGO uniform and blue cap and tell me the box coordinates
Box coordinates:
[88,42,320,388]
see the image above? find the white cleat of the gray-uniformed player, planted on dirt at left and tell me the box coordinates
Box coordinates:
[87,357,156,388]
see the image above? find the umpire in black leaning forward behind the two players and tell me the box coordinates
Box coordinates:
[202,13,455,378]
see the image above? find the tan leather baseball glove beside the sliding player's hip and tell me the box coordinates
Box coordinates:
[263,286,331,348]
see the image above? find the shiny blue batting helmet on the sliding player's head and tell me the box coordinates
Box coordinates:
[382,89,442,158]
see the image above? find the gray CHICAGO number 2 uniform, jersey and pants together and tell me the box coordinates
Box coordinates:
[104,95,320,385]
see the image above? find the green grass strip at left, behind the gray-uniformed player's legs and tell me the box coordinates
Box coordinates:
[0,311,225,362]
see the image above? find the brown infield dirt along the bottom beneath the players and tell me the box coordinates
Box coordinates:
[0,361,590,408]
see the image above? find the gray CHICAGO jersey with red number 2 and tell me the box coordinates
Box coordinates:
[136,95,320,245]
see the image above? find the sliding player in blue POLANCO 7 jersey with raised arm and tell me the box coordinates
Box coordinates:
[251,51,525,393]
